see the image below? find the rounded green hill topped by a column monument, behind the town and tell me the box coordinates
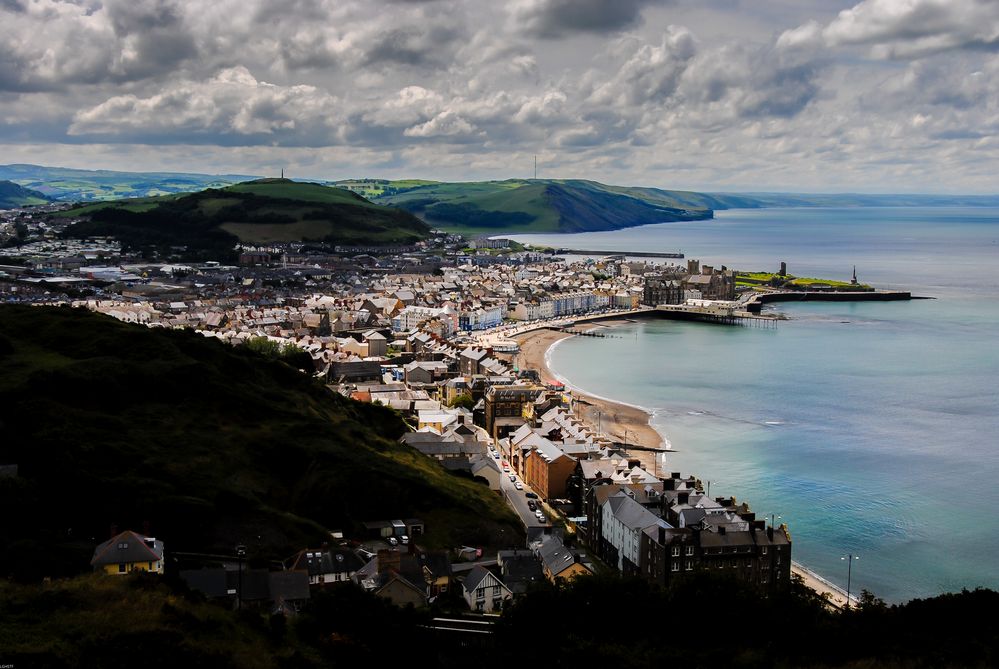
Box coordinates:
[63,179,429,260]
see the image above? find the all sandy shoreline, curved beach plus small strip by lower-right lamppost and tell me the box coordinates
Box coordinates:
[510,319,858,609]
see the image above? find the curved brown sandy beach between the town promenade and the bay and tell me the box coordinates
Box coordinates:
[513,321,663,474]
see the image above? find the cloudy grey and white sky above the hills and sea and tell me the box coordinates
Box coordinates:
[0,0,999,193]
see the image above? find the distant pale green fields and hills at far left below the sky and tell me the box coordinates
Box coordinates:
[0,165,254,202]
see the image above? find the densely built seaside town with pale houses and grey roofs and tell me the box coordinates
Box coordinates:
[0,201,816,613]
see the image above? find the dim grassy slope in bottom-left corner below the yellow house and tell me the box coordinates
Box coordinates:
[0,574,291,669]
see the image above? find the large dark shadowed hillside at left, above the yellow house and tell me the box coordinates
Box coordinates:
[0,306,520,577]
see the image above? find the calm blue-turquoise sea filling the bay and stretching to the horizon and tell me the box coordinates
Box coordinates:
[514,207,999,602]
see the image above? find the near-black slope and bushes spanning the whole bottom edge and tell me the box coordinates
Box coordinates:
[0,573,999,669]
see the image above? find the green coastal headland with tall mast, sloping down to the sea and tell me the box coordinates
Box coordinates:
[348,179,712,236]
